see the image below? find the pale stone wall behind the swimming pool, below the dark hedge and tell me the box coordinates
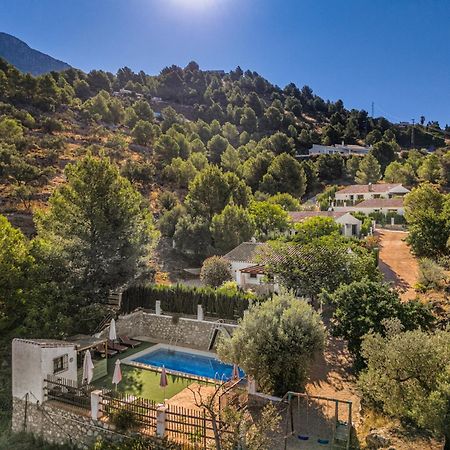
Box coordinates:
[108,310,237,350]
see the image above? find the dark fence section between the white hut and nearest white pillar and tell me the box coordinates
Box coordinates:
[44,375,96,410]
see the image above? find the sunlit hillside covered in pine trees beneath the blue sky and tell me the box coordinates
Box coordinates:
[0,57,450,258]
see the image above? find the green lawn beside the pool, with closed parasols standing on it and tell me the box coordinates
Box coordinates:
[93,342,193,402]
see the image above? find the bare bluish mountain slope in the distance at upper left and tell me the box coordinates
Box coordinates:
[0,31,71,75]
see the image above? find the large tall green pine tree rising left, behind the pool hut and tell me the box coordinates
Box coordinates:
[36,155,157,303]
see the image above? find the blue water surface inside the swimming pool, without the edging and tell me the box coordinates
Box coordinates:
[133,348,245,379]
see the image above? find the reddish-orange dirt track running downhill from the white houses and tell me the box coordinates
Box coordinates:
[376,230,418,300]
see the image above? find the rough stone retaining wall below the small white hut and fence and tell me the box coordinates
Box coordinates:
[11,398,124,449]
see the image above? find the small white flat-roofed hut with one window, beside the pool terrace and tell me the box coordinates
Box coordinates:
[12,339,77,403]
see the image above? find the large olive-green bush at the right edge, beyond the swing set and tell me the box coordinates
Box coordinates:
[358,321,450,439]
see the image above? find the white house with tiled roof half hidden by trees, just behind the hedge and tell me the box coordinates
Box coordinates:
[223,242,278,294]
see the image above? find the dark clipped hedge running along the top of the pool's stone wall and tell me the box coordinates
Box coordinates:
[121,285,262,320]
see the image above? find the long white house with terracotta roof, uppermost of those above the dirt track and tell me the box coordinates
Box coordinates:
[332,183,409,211]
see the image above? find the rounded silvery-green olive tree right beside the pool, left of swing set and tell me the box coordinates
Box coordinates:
[217,293,325,396]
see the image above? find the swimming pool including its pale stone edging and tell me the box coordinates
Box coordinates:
[123,344,245,380]
